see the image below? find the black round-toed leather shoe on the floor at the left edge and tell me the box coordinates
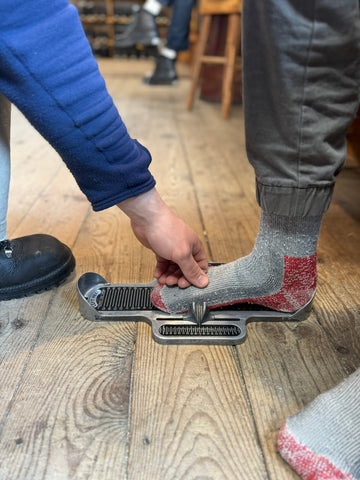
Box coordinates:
[0,234,75,301]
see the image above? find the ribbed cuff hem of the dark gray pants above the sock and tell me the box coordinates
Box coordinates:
[256,181,334,217]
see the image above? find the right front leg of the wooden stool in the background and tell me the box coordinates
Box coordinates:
[221,13,241,118]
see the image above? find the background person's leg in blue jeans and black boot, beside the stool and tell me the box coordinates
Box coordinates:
[144,0,195,85]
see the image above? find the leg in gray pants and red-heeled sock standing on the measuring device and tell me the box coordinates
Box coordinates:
[152,0,360,312]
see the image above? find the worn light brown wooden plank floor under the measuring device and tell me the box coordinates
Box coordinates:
[0,60,360,480]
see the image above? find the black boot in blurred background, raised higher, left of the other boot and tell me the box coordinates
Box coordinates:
[115,8,160,48]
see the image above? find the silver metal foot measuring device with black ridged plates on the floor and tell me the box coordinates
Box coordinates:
[77,272,313,345]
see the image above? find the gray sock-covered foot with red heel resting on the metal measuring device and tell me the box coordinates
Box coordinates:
[151,212,321,313]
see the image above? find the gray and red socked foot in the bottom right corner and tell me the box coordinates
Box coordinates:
[277,369,360,480]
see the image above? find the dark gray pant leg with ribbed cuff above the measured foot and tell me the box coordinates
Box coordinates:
[243,0,360,216]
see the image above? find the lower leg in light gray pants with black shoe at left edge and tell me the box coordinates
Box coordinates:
[0,94,75,301]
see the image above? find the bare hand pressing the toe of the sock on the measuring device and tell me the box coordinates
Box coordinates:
[118,189,209,288]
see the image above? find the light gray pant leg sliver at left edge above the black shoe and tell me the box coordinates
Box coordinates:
[0,93,11,241]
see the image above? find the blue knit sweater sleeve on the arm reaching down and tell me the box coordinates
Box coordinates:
[0,0,155,210]
